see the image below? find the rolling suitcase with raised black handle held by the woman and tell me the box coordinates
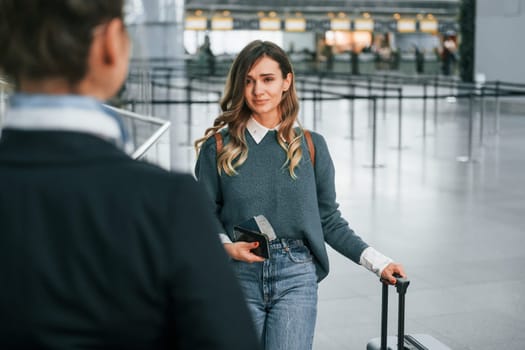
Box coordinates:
[366,277,451,350]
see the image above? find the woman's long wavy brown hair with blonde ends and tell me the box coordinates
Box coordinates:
[195,40,303,179]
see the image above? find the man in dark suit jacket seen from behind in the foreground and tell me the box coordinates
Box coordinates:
[0,0,259,350]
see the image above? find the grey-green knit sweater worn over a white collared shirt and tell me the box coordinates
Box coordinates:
[195,131,368,281]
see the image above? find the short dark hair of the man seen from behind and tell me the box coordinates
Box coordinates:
[0,0,124,84]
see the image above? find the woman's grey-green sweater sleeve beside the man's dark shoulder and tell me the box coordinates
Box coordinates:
[195,137,226,234]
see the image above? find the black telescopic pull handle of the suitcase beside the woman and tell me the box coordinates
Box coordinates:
[381,275,410,350]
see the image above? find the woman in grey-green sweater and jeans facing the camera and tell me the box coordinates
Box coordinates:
[195,40,405,350]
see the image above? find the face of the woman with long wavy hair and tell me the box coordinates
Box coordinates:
[244,56,292,128]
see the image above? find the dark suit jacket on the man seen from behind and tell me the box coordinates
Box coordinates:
[0,130,258,350]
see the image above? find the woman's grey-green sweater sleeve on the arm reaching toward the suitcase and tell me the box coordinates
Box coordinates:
[312,133,368,264]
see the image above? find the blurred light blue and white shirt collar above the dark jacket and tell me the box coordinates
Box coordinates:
[3,93,133,152]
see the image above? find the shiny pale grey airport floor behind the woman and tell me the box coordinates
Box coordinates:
[165,79,525,350]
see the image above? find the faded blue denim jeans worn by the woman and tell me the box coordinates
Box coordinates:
[233,239,317,350]
